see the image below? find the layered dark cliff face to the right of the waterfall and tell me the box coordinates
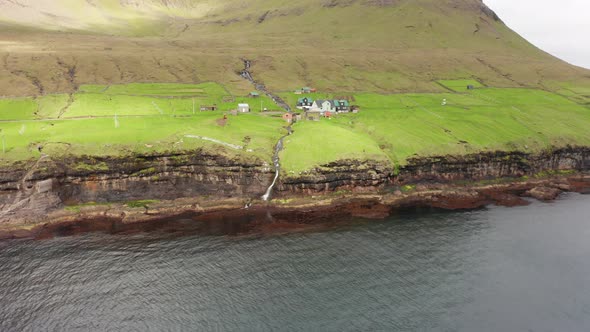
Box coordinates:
[279,147,590,193]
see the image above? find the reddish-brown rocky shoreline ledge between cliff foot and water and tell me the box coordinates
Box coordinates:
[0,172,590,240]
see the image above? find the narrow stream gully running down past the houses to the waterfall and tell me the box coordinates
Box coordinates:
[240,59,293,201]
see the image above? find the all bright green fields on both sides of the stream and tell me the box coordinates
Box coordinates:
[0,80,590,174]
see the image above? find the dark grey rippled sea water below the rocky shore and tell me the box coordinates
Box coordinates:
[0,194,590,331]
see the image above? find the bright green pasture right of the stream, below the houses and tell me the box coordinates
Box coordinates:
[282,88,590,172]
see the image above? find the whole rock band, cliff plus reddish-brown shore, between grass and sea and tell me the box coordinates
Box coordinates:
[0,147,590,238]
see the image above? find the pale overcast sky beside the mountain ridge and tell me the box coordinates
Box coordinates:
[484,0,590,68]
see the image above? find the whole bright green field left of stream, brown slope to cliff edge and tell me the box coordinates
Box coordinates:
[0,83,284,161]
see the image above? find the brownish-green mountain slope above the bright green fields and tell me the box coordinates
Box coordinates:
[0,0,590,95]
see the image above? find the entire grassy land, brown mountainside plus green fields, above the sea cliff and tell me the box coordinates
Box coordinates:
[0,0,590,174]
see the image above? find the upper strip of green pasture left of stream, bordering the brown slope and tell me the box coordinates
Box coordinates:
[0,83,276,121]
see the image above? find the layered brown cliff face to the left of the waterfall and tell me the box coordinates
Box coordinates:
[0,150,273,220]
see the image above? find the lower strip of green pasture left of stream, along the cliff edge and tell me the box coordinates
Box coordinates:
[0,112,284,160]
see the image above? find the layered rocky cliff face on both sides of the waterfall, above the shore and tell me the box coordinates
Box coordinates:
[0,147,590,221]
